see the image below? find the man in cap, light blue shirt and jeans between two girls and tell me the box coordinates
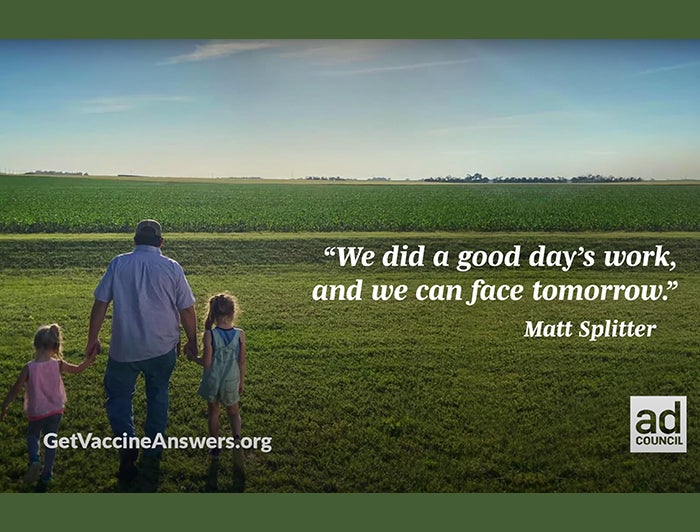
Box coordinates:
[85,220,197,483]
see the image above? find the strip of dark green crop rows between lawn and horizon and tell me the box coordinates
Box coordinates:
[0,176,700,233]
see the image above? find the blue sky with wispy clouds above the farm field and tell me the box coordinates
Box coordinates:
[0,40,700,179]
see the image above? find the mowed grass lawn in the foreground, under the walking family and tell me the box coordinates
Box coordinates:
[0,233,700,492]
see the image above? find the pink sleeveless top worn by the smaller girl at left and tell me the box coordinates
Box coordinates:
[24,359,66,421]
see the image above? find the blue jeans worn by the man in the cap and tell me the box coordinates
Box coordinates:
[104,349,177,456]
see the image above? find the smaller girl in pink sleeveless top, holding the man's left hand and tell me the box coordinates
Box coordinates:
[2,323,96,489]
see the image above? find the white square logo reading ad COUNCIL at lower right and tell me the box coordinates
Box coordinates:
[630,395,687,453]
